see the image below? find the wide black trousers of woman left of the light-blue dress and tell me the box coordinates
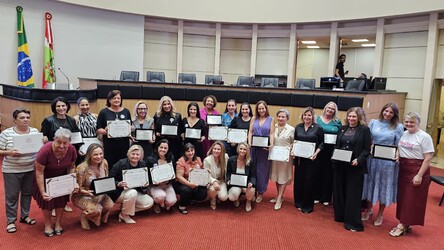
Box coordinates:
[333,163,364,231]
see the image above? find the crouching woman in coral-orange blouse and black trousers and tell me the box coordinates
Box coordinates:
[173,143,210,214]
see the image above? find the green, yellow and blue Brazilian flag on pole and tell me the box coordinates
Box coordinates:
[16,6,34,87]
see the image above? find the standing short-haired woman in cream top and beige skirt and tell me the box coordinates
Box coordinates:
[270,109,294,210]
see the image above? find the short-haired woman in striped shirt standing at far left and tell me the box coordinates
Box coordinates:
[0,108,42,233]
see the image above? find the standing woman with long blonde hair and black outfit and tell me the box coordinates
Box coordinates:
[154,96,183,162]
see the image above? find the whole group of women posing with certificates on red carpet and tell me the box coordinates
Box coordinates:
[0,90,434,237]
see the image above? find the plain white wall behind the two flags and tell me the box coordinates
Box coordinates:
[0,0,144,87]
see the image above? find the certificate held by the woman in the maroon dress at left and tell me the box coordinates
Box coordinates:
[45,173,76,198]
